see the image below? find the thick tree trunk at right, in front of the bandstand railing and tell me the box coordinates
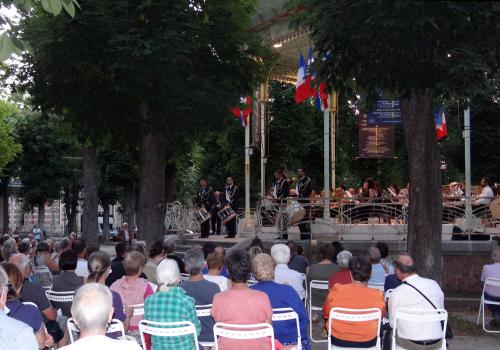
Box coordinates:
[401,89,443,284]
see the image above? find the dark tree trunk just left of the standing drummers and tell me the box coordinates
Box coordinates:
[137,103,166,243]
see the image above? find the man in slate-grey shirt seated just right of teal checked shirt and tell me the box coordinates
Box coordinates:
[181,248,219,342]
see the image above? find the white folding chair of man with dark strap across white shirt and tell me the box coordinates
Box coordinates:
[391,308,448,350]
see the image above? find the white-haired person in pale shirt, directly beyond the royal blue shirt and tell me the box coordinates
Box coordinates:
[271,243,306,299]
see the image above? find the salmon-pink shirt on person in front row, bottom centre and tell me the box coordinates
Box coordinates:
[212,289,273,350]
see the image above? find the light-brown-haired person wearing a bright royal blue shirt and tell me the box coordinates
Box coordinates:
[250,253,311,350]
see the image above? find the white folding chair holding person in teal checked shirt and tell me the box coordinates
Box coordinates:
[139,320,198,349]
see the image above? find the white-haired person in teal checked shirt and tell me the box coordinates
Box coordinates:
[144,258,201,350]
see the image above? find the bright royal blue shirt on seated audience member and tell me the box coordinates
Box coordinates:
[250,281,309,344]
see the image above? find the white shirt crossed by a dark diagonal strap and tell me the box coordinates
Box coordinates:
[389,274,444,340]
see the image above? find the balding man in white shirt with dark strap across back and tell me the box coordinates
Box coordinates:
[389,253,444,349]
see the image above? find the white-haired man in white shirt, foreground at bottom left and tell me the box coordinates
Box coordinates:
[61,283,141,350]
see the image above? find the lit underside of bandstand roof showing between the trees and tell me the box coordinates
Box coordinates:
[250,0,312,84]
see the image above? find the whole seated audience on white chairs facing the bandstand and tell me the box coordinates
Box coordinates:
[0,232,500,350]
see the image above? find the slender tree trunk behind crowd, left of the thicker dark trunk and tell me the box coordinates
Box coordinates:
[82,146,99,245]
